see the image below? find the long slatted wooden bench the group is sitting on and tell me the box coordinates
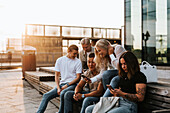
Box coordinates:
[26,68,170,113]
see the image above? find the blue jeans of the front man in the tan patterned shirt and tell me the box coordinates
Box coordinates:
[64,91,100,113]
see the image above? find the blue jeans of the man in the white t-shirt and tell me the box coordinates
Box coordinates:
[37,83,76,113]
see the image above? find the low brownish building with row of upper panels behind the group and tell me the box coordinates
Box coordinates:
[24,24,122,64]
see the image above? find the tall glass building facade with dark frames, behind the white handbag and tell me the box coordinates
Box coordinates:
[124,0,170,65]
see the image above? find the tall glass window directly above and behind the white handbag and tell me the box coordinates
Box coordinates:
[142,0,168,64]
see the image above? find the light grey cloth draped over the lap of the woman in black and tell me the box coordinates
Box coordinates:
[92,97,119,113]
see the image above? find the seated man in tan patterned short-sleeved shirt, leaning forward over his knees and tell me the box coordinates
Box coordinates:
[64,53,104,113]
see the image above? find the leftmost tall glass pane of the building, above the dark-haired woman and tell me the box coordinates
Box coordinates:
[125,0,142,62]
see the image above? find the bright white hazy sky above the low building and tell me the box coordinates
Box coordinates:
[0,0,124,50]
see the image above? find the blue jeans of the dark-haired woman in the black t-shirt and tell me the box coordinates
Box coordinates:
[85,97,137,113]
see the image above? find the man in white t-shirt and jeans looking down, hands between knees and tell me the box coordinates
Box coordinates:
[37,45,82,113]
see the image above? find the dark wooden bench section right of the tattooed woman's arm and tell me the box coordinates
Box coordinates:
[138,83,170,113]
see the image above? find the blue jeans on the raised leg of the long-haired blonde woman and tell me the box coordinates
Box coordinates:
[102,70,118,90]
